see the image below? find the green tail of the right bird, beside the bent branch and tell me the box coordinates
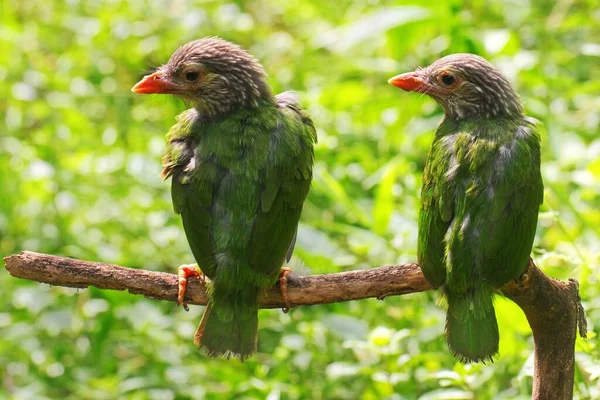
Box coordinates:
[446,288,500,363]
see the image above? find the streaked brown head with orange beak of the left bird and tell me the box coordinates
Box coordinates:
[131,37,271,116]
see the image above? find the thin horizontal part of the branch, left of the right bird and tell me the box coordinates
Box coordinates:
[4,251,432,308]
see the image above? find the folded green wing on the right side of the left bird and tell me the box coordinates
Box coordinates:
[248,93,317,276]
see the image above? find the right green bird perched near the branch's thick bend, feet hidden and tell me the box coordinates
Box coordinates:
[389,54,544,362]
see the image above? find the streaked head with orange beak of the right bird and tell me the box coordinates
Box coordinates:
[388,54,523,119]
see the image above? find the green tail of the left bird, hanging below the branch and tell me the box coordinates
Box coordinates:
[194,286,260,361]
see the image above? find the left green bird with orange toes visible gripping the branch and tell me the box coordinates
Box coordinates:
[132,38,317,361]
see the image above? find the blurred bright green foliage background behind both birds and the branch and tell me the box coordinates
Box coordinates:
[0,0,600,400]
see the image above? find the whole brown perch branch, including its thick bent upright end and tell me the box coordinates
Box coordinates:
[4,251,585,400]
